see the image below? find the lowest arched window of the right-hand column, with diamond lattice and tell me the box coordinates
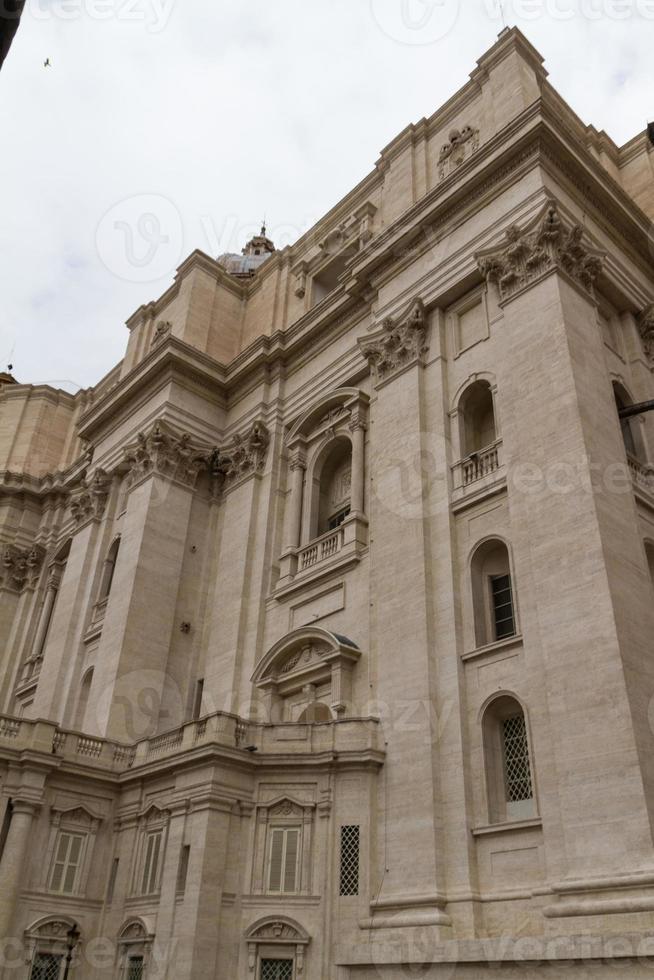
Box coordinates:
[482,695,536,823]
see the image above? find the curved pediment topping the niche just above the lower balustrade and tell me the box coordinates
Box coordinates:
[252,626,361,685]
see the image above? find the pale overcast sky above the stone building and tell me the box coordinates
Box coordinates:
[0,0,654,391]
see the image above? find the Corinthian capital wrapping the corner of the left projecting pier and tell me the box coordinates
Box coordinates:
[125,422,208,489]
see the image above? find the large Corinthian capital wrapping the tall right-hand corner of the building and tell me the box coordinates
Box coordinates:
[477,201,605,300]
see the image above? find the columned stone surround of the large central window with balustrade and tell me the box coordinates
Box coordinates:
[276,388,370,594]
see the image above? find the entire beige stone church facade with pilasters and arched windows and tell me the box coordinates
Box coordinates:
[0,30,654,980]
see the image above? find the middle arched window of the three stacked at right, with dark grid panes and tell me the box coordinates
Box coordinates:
[470,538,517,647]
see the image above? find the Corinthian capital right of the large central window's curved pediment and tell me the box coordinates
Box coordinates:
[359,299,428,384]
